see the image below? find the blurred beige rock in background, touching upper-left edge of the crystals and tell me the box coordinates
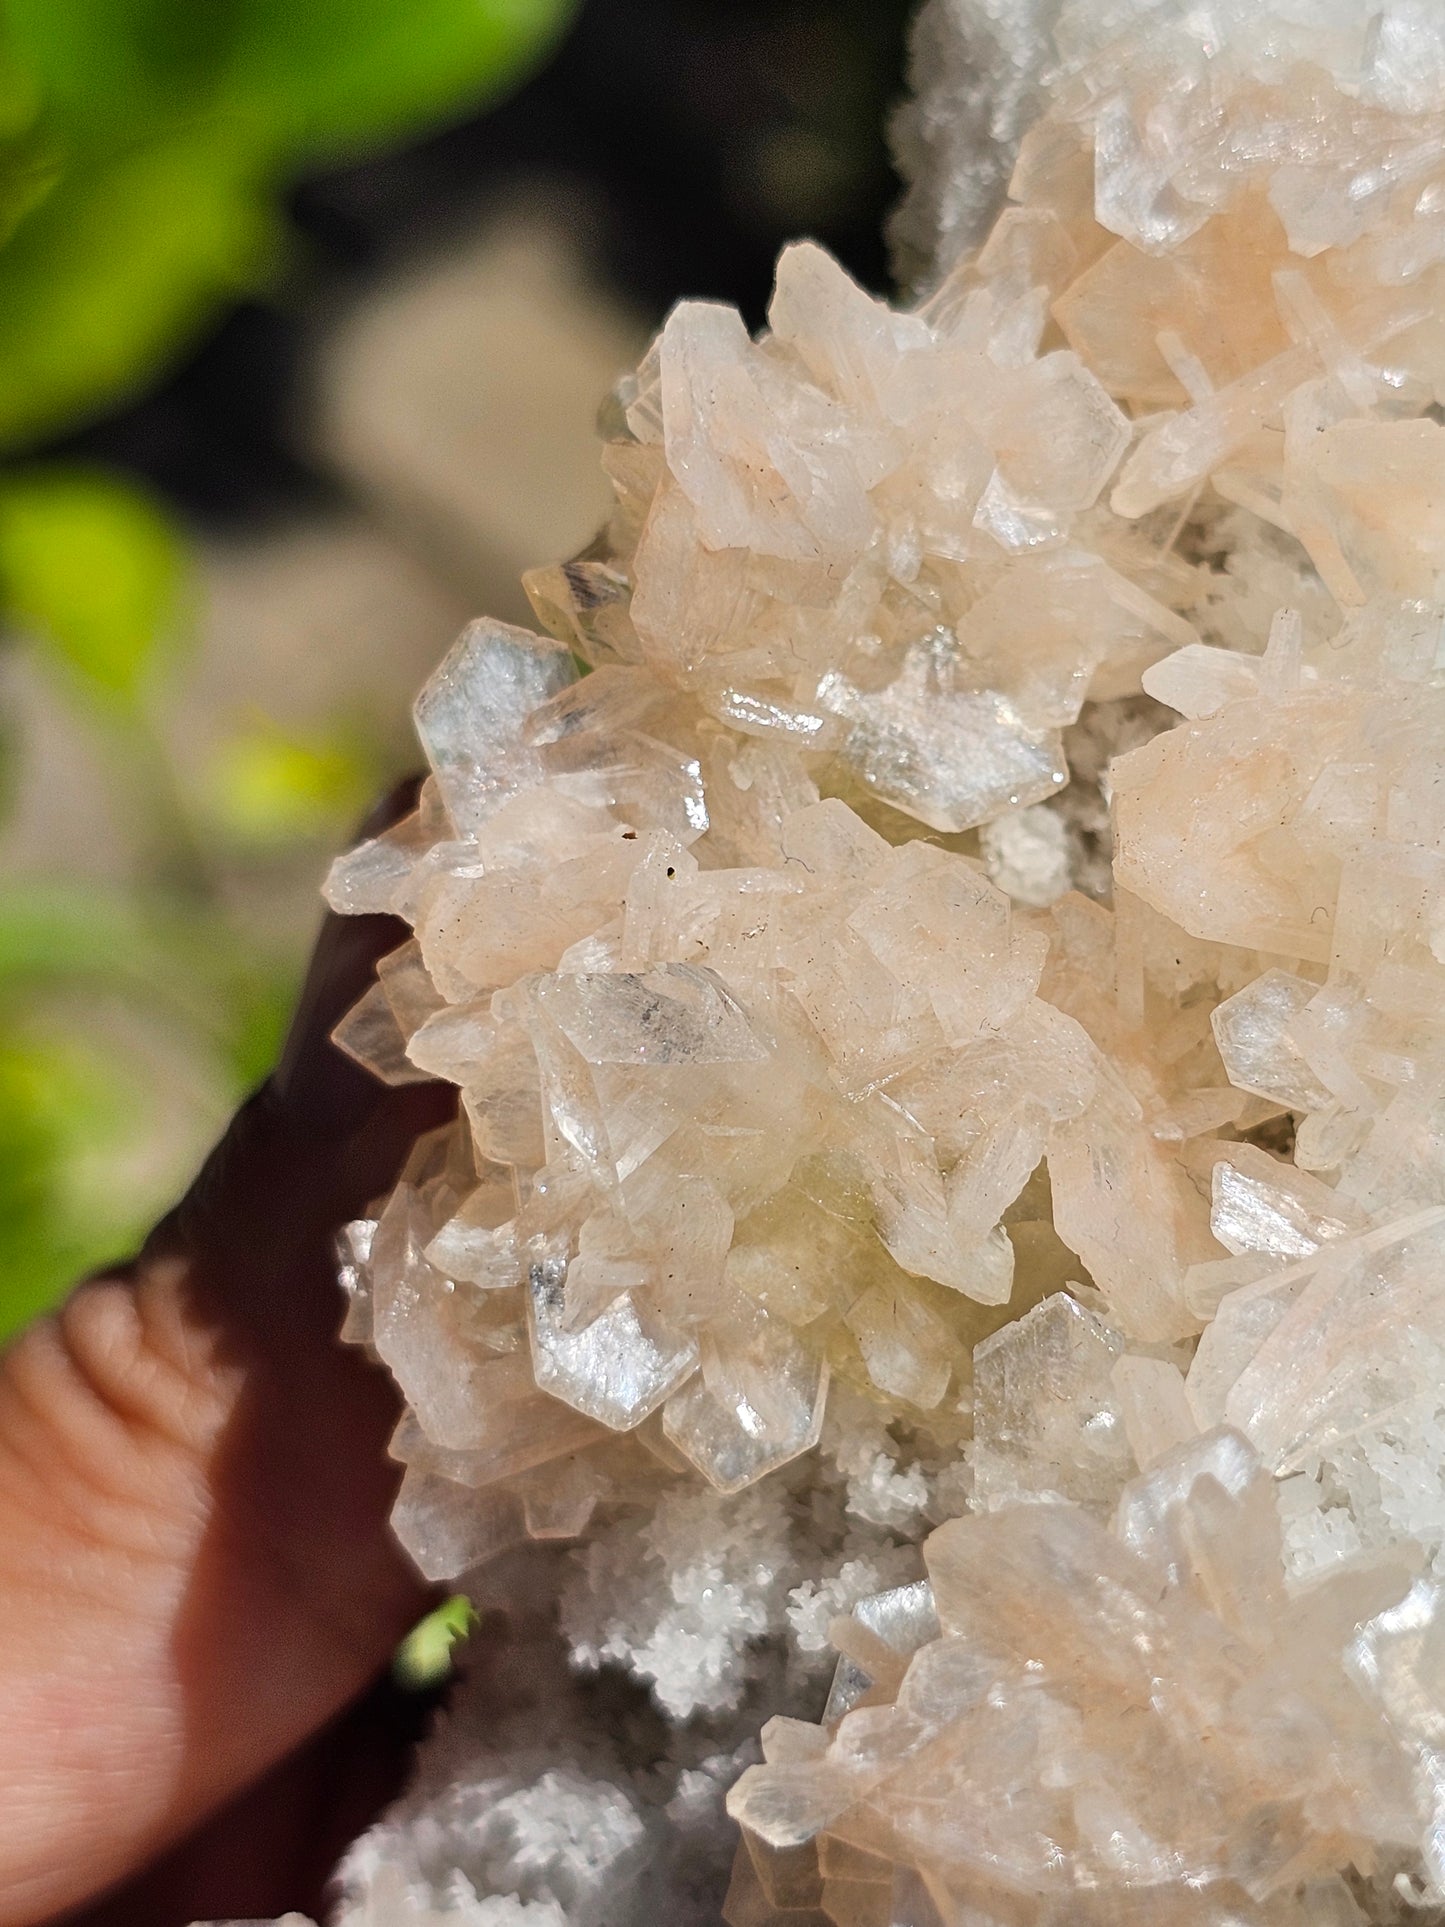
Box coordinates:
[321,206,645,619]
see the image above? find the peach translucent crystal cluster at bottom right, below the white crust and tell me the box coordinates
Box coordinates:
[728,1434,1426,1923]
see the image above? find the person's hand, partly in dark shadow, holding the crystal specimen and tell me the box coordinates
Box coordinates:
[0,796,453,1927]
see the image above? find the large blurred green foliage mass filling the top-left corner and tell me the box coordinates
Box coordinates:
[0,0,570,447]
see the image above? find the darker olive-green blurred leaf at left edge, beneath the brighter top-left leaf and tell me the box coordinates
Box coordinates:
[0,125,281,447]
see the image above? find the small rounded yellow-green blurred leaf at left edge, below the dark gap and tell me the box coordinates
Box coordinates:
[0,462,189,707]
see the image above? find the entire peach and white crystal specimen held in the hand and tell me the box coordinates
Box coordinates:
[217,0,1445,1927]
